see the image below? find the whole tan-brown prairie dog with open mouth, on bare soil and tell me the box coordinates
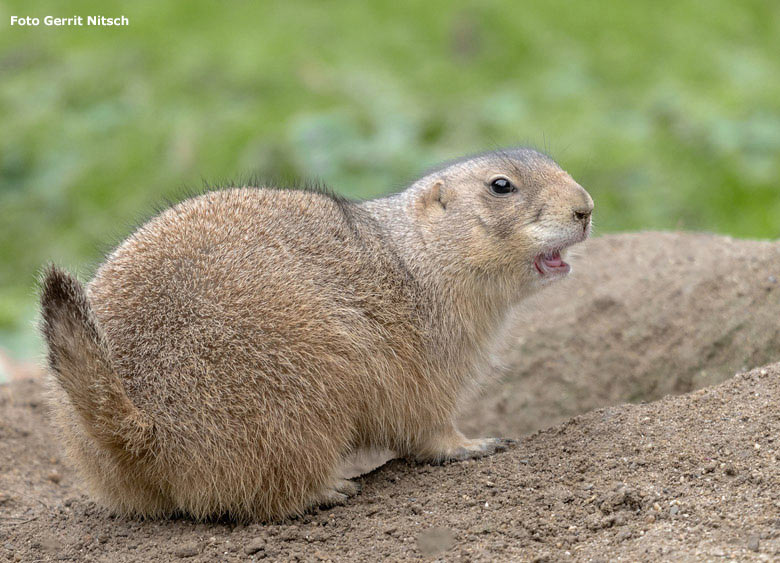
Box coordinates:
[41,149,593,520]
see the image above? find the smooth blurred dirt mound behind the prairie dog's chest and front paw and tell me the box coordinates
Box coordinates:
[461,233,780,436]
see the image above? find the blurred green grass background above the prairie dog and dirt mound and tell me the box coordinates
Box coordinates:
[0,0,780,368]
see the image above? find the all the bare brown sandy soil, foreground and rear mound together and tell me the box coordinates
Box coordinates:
[0,233,780,562]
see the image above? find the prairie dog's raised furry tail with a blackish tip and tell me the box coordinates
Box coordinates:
[41,266,153,455]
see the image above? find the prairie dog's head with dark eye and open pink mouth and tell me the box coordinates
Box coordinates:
[410,148,593,286]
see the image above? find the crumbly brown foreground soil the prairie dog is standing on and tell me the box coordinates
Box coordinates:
[0,364,780,562]
